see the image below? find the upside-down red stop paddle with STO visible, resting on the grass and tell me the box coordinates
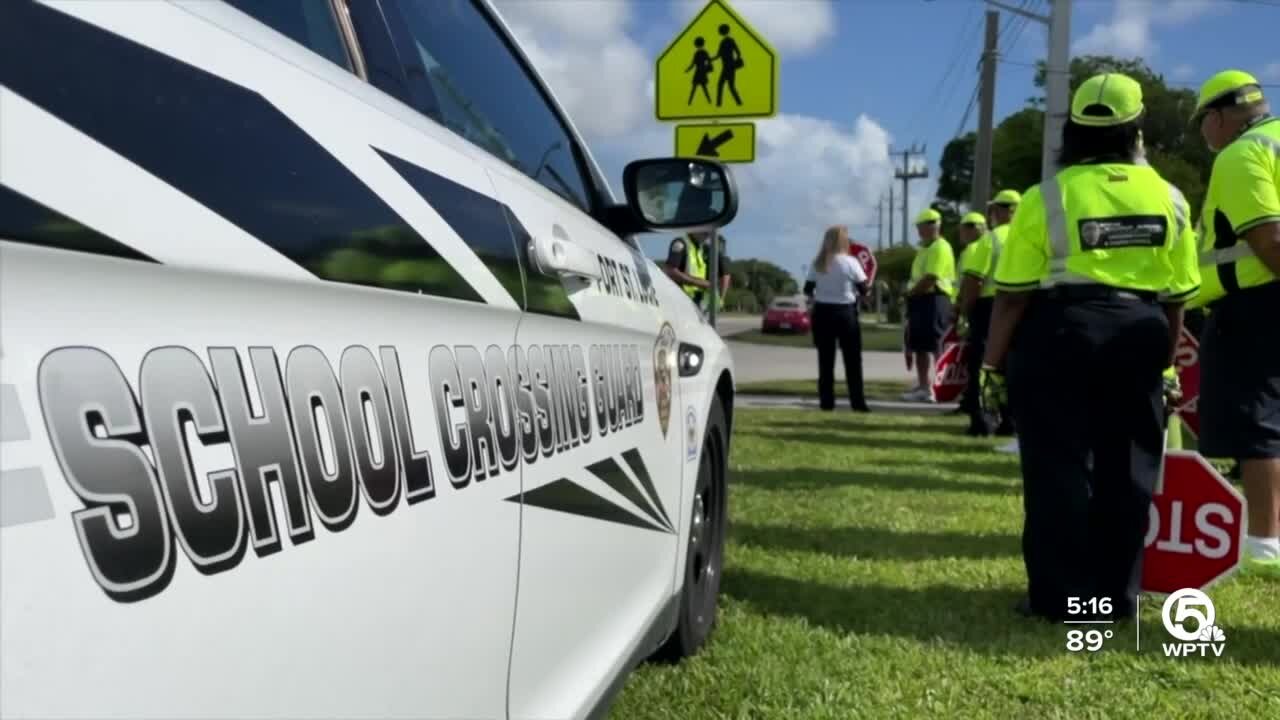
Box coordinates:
[1142,450,1244,594]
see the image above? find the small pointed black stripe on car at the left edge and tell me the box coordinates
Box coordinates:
[0,184,156,263]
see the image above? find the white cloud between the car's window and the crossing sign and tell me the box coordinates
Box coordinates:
[497,0,653,138]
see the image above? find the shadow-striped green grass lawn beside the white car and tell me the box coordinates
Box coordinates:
[611,410,1280,720]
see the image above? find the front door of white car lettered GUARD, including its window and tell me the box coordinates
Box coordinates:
[366,0,682,717]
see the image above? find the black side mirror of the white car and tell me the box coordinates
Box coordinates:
[622,158,737,231]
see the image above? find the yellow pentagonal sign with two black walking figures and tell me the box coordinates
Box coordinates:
[654,0,781,120]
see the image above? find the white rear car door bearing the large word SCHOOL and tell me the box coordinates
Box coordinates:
[0,0,522,717]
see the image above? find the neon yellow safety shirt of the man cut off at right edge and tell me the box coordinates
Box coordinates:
[1193,118,1280,306]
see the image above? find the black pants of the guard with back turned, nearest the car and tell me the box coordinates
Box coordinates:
[1007,297,1170,618]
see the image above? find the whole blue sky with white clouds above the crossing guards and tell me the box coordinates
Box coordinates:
[499,0,1280,278]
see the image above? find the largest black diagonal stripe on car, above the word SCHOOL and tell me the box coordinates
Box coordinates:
[0,0,483,301]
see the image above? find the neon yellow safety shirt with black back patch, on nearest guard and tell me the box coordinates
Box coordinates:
[996,163,1201,302]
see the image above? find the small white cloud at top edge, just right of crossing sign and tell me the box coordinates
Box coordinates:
[675,0,836,54]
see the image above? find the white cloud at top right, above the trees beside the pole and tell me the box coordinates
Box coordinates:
[1073,0,1219,59]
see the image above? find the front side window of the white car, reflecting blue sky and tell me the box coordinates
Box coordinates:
[386,0,591,211]
